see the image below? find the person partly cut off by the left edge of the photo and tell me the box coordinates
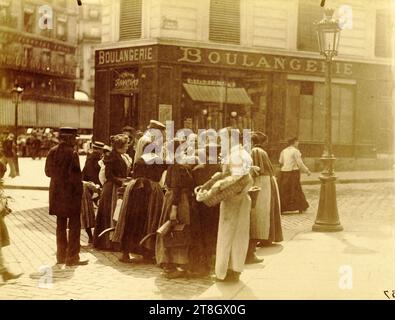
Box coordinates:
[0,181,22,281]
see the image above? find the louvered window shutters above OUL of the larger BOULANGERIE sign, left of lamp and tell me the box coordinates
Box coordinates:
[209,0,240,44]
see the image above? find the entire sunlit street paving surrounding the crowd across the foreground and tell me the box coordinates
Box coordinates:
[0,183,395,300]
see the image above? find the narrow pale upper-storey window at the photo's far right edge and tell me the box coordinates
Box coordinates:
[375,11,392,58]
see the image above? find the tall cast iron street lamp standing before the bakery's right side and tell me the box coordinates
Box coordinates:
[313,9,343,232]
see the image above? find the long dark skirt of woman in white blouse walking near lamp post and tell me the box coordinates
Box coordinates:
[278,170,309,212]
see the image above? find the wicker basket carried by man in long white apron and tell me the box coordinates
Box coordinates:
[195,175,251,207]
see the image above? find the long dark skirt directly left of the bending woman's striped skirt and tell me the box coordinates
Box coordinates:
[93,181,117,250]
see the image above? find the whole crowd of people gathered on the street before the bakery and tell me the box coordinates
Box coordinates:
[0,120,310,281]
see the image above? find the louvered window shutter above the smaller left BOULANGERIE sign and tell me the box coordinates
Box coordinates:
[119,0,142,40]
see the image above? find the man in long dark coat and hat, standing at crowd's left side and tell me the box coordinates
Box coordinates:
[45,127,88,266]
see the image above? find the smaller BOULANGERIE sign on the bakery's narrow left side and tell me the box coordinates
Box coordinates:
[97,47,153,66]
